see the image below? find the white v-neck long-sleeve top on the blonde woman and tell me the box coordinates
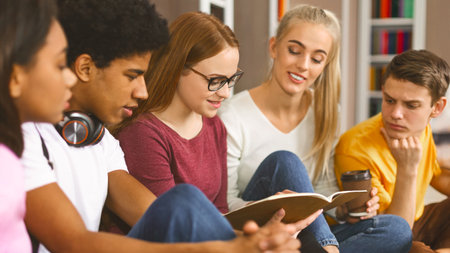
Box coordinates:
[219,91,339,211]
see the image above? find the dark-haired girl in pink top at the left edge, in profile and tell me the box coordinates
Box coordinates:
[0,0,75,252]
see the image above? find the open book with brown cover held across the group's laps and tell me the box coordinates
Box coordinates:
[225,190,367,229]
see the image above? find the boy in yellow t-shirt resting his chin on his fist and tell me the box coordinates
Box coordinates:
[335,50,450,253]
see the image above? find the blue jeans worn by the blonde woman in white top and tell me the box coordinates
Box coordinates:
[242,151,412,253]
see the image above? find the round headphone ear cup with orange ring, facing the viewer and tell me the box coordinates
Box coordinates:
[57,112,94,147]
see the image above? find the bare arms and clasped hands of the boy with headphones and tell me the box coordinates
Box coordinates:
[25,171,300,252]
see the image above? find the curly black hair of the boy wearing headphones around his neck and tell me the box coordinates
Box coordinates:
[58,0,169,68]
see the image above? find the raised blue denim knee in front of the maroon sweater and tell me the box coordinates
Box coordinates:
[127,184,236,242]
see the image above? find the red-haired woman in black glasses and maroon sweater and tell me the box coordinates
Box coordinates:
[114,13,243,213]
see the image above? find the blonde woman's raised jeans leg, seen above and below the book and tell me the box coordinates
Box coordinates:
[242,151,338,246]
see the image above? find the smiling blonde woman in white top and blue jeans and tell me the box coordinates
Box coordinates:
[219,5,410,252]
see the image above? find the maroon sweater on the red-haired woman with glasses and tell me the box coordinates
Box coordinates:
[117,113,228,213]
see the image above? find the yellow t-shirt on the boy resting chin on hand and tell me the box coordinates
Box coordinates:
[334,114,441,220]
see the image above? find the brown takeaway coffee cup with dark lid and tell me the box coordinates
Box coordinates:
[341,170,372,217]
